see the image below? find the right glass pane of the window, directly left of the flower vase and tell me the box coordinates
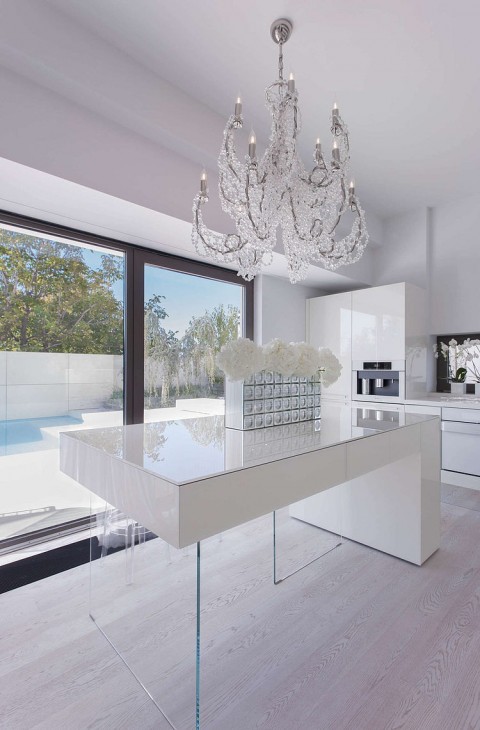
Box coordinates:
[144,264,244,421]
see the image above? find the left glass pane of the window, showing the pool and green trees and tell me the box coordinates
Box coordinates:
[0,225,125,546]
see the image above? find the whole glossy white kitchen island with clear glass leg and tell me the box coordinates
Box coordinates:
[61,404,440,728]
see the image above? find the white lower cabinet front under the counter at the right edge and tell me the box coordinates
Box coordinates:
[442,408,480,476]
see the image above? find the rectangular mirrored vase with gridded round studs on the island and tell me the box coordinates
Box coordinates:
[225,370,321,431]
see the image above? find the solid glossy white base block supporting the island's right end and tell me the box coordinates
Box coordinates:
[290,411,440,565]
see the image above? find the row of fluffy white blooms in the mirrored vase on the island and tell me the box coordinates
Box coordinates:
[217,337,342,385]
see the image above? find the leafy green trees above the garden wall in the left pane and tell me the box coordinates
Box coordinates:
[0,229,123,354]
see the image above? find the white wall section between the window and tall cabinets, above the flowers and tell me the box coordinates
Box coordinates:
[255,274,325,344]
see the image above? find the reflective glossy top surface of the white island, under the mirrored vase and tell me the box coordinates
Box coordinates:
[62,404,432,486]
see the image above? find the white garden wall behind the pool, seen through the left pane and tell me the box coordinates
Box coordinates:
[0,352,123,420]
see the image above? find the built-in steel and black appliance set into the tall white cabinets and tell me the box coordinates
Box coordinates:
[352,360,405,403]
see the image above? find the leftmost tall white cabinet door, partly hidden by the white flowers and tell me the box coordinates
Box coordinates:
[307,292,352,400]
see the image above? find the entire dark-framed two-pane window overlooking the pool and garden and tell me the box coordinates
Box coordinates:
[0,213,253,552]
